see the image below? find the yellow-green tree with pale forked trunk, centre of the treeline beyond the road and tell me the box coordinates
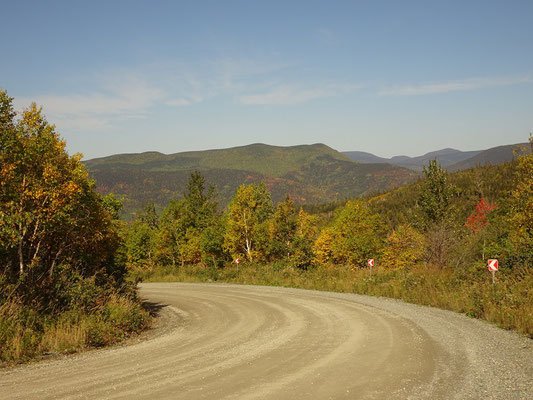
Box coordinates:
[224,183,274,261]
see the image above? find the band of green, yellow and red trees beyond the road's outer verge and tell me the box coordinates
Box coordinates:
[126,146,533,270]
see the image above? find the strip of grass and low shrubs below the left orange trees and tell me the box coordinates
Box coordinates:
[0,294,151,366]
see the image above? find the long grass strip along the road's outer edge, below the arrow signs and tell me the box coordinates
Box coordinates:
[130,262,533,338]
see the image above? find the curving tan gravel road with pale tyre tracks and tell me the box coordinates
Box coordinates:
[0,283,533,400]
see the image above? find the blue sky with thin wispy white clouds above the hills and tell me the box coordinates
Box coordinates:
[0,0,533,158]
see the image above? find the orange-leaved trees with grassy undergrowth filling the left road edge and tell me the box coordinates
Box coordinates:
[0,91,150,362]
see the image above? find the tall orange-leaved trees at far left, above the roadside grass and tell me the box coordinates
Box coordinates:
[0,91,124,308]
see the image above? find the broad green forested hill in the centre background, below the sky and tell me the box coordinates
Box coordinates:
[85,144,417,213]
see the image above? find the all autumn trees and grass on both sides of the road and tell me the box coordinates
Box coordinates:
[0,87,533,364]
